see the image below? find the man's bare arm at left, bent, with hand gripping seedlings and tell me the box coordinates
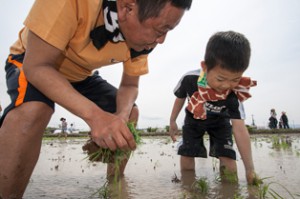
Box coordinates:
[23,32,136,150]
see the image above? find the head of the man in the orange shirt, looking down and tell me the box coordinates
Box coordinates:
[117,0,192,51]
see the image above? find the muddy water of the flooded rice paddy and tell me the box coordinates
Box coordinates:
[24,135,300,199]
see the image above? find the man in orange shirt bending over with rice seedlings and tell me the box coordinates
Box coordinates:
[0,0,192,199]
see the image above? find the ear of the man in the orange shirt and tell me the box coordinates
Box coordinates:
[117,0,136,21]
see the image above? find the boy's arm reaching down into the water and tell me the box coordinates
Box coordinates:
[231,119,256,184]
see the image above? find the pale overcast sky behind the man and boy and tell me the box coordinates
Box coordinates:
[0,0,300,130]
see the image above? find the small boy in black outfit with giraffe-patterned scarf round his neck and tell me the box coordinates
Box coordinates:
[170,31,256,184]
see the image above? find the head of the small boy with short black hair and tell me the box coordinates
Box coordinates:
[201,31,251,93]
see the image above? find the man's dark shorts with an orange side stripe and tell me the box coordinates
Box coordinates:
[0,54,117,126]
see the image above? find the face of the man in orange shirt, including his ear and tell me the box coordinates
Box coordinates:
[118,3,185,51]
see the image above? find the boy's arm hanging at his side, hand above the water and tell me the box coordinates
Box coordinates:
[169,98,185,142]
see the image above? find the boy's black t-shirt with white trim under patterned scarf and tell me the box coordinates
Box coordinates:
[174,70,245,119]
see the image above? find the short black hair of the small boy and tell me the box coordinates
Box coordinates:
[204,31,251,72]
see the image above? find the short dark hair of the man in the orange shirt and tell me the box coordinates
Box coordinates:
[136,0,192,22]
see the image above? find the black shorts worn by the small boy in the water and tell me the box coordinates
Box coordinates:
[178,109,236,160]
